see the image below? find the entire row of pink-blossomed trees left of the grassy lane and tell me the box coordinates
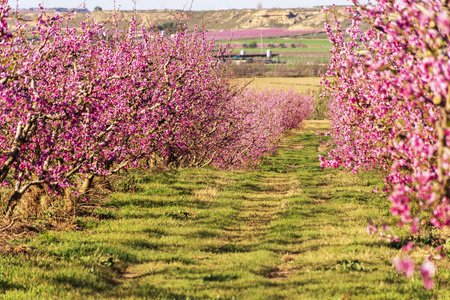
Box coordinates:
[0,0,313,217]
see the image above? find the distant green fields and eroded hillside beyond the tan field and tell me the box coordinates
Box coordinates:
[8,7,334,77]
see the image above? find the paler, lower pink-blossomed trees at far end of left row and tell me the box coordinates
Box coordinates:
[215,89,314,167]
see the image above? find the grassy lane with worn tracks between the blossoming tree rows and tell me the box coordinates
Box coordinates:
[0,121,450,299]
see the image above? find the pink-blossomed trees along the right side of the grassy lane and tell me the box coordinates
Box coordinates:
[320,0,450,289]
